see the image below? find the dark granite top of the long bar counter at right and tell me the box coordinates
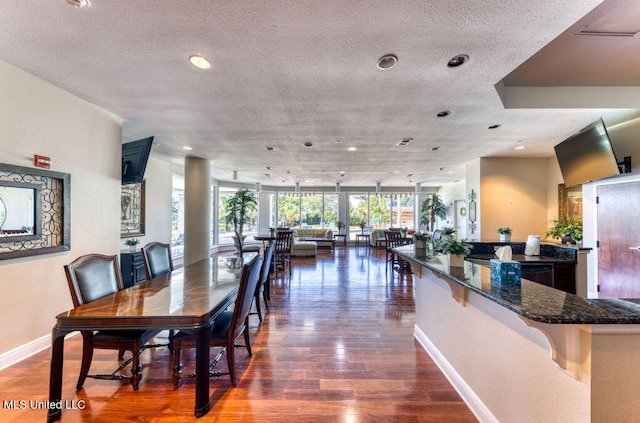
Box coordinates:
[395,246,640,325]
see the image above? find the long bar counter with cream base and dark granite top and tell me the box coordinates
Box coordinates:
[396,246,640,423]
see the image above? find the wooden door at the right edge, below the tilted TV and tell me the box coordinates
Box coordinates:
[597,182,640,298]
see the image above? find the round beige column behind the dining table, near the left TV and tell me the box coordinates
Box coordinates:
[184,157,211,266]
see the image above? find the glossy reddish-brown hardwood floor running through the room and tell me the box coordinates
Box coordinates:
[0,247,477,423]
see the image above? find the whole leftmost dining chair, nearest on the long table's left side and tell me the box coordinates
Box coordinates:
[64,254,158,390]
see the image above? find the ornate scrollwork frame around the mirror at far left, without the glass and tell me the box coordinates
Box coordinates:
[0,163,71,260]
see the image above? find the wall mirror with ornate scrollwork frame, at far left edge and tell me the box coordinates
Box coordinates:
[0,164,71,260]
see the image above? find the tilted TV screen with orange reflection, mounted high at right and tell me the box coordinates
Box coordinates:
[555,119,620,187]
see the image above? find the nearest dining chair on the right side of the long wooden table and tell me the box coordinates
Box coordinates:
[173,255,262,389]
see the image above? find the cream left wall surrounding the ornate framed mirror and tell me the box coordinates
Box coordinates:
[0,61,122,368]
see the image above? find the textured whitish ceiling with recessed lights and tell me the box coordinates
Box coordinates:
[0,0,640,187]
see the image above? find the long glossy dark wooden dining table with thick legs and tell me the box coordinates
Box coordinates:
[47,253,257,422]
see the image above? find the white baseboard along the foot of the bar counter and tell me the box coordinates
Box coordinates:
[413,325,499,423]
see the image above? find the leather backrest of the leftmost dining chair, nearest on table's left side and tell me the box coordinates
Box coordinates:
[64,254,123,307]
